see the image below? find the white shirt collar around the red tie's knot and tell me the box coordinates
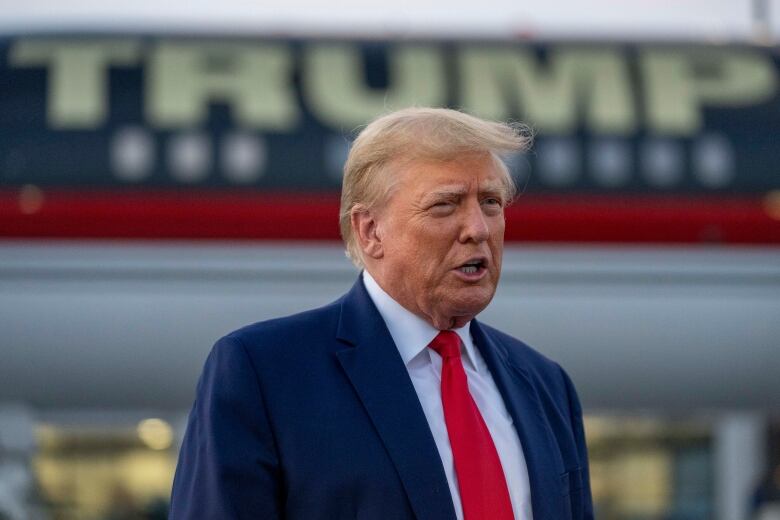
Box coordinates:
[363,270,479,370]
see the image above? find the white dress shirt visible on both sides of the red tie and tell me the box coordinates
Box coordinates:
[363,271,532,520]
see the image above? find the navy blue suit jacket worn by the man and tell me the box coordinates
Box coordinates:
[170,279,593,520]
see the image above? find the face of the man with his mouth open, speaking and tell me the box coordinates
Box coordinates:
[372,154,506,329]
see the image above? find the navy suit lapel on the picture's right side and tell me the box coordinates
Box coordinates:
[471,320,567,520]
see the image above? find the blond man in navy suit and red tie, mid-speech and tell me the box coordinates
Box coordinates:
[170,108,593,520]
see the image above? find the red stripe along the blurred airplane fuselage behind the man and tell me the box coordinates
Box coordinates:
[0,187,780,244]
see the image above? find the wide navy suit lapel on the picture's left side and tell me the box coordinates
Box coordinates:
[336,279,455,520]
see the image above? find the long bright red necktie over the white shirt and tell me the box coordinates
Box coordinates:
[428,330,514,520]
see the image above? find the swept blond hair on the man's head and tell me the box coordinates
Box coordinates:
[339,108,531,267]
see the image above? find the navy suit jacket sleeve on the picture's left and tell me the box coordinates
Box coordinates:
[169,336,283,520]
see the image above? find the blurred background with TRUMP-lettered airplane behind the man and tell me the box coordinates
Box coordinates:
[0,0,780,520]
